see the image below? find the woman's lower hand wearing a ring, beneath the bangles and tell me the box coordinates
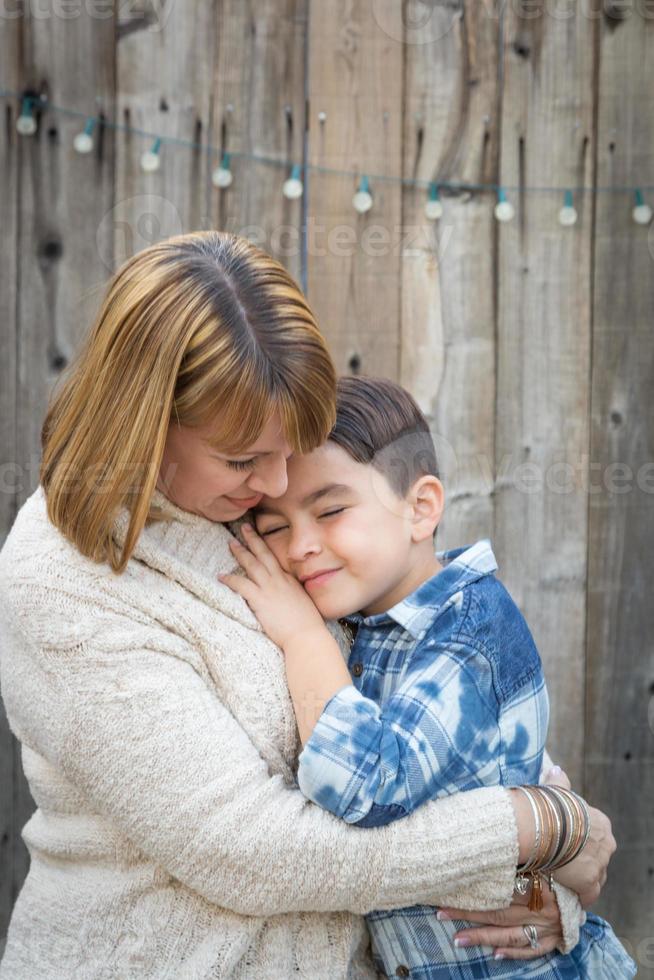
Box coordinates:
[438,882,563,960]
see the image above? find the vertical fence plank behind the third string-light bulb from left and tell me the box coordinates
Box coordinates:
[113,0,216,267]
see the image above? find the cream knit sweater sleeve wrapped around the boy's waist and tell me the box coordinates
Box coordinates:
[3,587,518,916]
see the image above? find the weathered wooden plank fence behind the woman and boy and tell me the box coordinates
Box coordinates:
[0,0,654,964]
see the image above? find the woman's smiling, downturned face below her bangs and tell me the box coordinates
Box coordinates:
[157,413,291,521]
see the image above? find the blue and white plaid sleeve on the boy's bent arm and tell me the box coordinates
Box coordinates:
[298,641,508,826]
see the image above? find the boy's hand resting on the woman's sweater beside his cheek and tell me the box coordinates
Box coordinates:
[218,524,328,649]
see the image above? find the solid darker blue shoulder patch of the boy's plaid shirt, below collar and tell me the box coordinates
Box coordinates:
[425,552,542,700]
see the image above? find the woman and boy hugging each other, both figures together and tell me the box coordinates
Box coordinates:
[0,232,635,980]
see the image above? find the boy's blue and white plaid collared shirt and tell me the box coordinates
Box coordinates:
[298,541,633,980]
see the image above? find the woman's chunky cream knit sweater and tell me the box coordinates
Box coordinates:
[0,488,579,980]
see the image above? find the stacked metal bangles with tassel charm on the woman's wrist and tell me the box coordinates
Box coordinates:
[515,786,590,912]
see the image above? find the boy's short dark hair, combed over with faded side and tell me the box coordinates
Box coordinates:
[328,376,438,497]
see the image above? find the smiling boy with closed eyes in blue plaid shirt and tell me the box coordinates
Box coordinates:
[222,378,635,980]
